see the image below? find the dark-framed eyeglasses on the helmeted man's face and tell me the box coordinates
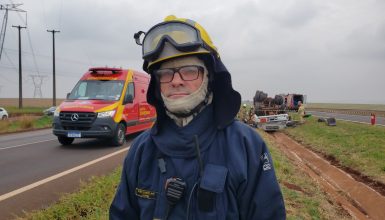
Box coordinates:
[154,65,204,83]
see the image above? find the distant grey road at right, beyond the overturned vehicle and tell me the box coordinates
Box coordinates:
[306,111,385,126]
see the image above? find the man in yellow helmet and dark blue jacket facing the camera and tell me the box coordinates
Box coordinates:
[110,16,285,220]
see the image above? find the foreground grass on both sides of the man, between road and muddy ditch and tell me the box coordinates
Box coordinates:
[18,132,350,220]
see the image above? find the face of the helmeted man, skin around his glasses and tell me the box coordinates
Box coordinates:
[159,56,204,99]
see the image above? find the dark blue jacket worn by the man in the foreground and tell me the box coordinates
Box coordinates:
[110,106,285,220]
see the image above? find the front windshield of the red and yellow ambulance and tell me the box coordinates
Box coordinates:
[68,80,124,101]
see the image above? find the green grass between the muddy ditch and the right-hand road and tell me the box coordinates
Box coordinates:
[285,117,385,184]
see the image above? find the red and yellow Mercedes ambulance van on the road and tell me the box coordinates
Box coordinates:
[52,67,156,146]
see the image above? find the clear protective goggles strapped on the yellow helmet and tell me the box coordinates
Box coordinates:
[134,21,204,61]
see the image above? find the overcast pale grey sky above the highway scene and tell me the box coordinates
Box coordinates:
[0,0,385,104]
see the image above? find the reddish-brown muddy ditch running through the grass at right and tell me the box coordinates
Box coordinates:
[273,132,385,220]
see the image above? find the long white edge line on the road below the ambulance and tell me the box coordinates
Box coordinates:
[0,146,130,202]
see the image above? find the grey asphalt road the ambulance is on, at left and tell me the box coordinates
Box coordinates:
[0,129,133,219]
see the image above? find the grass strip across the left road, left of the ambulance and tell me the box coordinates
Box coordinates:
[0,116,53,134]
